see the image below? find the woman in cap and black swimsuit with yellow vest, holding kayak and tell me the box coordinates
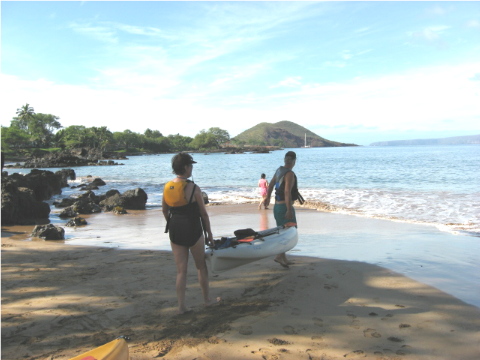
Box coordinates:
[162,153,218,314]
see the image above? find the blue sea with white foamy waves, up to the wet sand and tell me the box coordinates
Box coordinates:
[22,145,480,236]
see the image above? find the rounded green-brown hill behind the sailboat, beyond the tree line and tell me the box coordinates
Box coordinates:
[232,120,357,148]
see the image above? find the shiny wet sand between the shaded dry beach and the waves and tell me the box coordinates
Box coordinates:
[2,202,480,308]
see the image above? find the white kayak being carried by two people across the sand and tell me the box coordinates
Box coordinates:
[206,226,298,272]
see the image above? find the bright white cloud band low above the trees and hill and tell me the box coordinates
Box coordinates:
[0,63,480,136]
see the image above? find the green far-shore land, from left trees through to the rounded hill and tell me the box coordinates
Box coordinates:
[2,104,352,160]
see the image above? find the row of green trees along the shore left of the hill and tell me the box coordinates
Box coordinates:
[2,104,231,153]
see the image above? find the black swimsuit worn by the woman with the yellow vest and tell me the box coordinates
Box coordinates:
[165,185,203,247]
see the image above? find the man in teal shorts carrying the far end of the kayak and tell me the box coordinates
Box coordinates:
[265,151,298,268]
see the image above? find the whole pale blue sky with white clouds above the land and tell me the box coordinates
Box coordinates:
[0,1,480,145]
